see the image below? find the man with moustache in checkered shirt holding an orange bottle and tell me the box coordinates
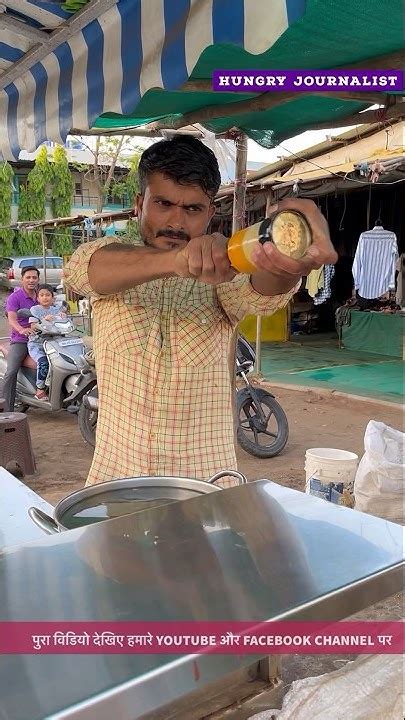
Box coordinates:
[65,135,336,485]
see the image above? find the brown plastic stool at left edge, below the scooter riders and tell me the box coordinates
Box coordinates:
[0,412,35,475]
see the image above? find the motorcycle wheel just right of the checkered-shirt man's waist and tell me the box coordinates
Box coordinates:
[236,388,288,458]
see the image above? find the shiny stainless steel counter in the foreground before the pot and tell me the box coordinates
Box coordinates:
[0,466,403,720]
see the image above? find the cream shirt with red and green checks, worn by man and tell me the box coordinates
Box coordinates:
[65,238,296,485]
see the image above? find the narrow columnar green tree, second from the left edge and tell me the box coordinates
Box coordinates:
[17,146,52,255]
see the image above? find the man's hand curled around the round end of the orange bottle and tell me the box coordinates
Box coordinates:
[252,198,338,280]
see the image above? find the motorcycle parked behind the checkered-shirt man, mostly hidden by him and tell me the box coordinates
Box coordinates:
[77,336,288,458]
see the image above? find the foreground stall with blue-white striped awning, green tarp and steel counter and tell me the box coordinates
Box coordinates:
[0,0,405,720]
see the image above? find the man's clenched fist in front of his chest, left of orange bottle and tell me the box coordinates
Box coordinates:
[174,233,236,285]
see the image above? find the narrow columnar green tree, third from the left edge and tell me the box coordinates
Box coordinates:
[51,145,73,255]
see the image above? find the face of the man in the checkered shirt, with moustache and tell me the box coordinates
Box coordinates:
[136,173,215,250]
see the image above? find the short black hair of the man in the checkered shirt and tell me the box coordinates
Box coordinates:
[138,135,221,198]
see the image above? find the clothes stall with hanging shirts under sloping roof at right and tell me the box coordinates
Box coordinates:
[216,120,405,346]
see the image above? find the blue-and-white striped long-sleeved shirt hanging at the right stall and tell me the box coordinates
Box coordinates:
[352,225,398,300]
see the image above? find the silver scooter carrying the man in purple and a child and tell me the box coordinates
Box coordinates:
[0,309,97,413]
